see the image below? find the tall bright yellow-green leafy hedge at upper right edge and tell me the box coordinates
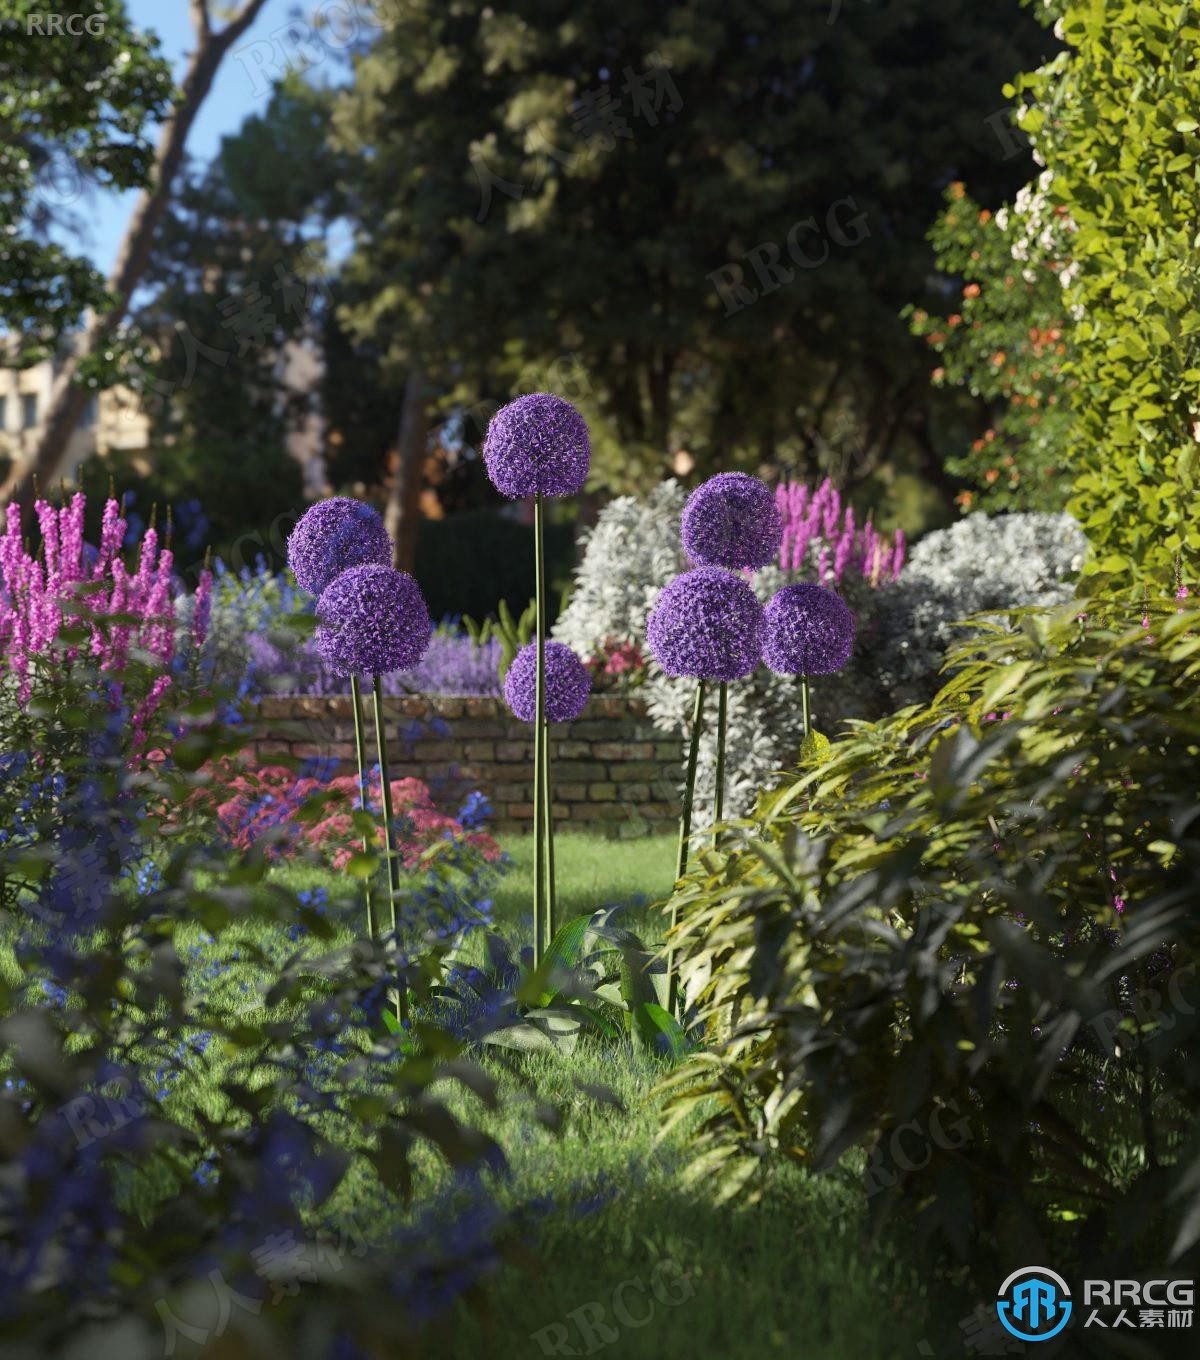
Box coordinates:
[1016,0,1200,589]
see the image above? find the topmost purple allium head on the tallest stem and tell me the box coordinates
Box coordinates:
[483,392,592,499]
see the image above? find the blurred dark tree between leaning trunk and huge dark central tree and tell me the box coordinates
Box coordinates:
[112,79,341,558]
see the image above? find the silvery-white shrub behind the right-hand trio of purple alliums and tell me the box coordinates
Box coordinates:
[554,495,1087,828]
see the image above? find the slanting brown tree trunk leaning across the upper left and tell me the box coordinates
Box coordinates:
[0,0,267,506]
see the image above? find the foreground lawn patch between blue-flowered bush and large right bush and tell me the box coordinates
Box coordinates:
[438,1047,941,1360]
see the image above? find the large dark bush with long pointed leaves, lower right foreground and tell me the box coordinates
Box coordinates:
[668,601,1200,1289]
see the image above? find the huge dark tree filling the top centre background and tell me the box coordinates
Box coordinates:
[336,0,1049,524]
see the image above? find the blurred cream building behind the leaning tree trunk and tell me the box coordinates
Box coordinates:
[0,359,150,480]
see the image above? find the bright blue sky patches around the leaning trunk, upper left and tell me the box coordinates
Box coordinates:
[75,0,303,273]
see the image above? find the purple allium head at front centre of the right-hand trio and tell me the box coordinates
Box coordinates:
[646,567,763,680]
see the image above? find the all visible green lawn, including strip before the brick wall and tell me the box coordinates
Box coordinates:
[7,835,946,1360]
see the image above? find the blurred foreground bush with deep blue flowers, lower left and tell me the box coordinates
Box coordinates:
[0,614,558,1355]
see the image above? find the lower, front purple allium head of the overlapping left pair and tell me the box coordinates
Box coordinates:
[317,566,433,676]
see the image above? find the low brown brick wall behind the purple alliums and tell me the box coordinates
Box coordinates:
[256,695,680,836]
